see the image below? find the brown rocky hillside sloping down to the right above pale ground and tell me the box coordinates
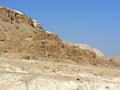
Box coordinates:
[0,7,105,64]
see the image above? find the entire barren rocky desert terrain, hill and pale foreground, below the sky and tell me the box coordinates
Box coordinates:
[0,7,120,90]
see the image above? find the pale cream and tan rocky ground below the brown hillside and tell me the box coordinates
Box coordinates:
[0,58,120,90]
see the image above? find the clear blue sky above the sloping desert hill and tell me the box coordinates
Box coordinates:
[0,0,120,56]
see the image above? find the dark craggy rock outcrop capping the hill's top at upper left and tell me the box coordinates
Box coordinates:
[0,7,42,28]
